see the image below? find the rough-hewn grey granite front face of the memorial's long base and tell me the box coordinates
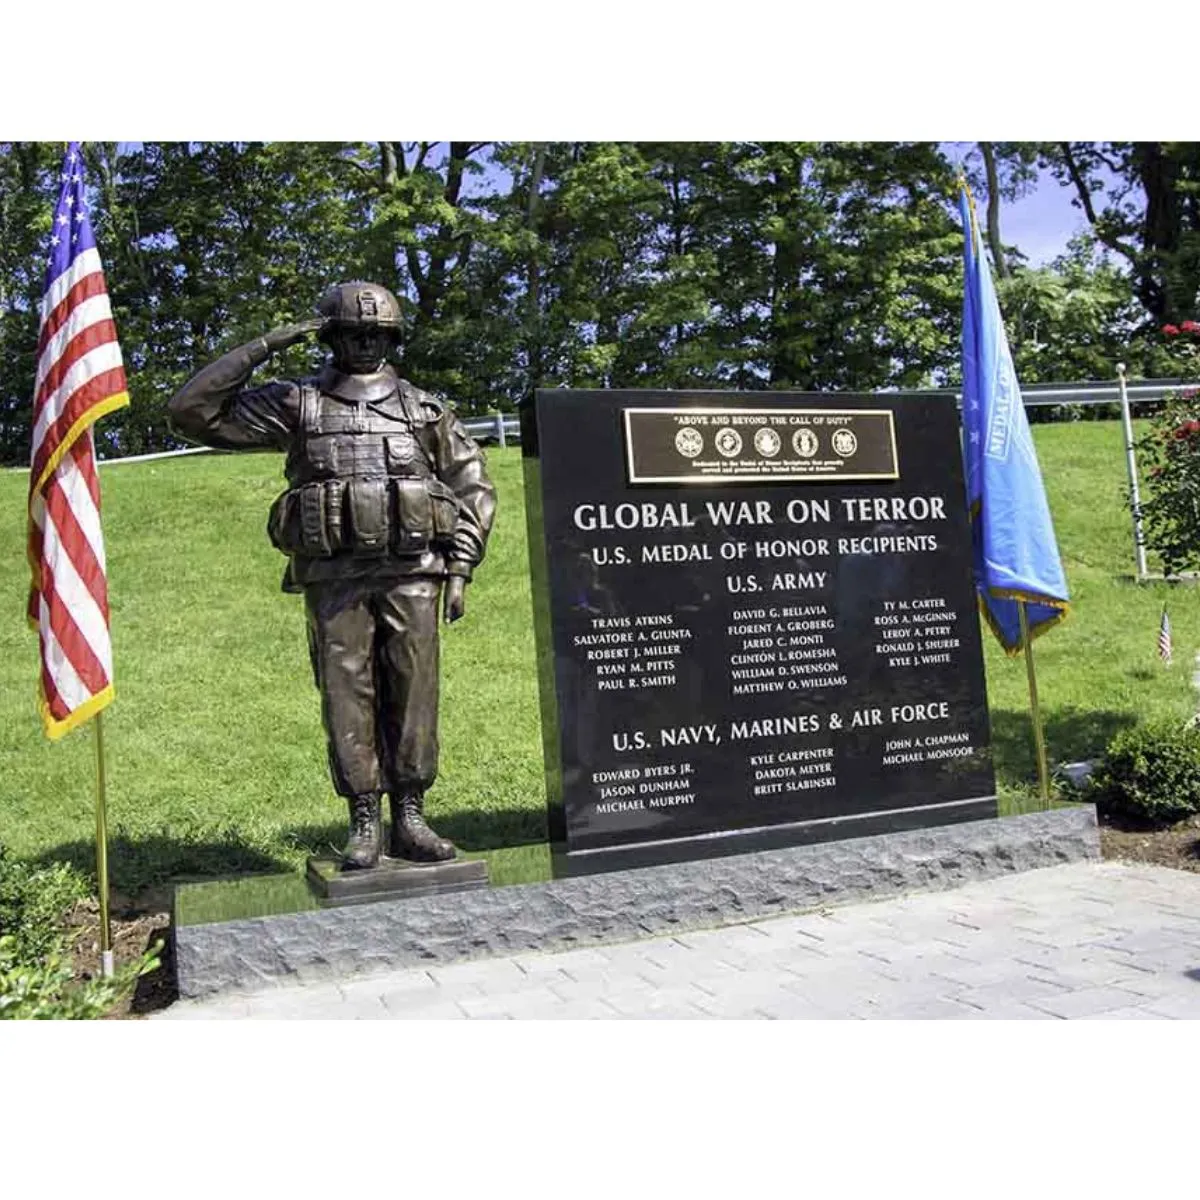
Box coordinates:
[173,805,1100,997]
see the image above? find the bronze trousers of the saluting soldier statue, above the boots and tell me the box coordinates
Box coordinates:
[305,576,442,796]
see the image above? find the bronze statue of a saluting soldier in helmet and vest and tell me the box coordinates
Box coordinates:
[170,290,496,869]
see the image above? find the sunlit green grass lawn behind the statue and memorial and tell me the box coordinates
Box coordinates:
[0,422,1200,894]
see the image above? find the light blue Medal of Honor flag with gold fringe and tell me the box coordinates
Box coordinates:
[959,186,1068,654]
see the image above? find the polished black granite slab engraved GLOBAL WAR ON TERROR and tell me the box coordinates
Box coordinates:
[521,389,996,875]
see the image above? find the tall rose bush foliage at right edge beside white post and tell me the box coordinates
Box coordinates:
[1127,388,1200,576]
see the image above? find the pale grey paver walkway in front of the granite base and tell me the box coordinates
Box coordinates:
[158,863,1200,1019]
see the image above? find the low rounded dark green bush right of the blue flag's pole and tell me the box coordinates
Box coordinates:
[1088,721,1200,826]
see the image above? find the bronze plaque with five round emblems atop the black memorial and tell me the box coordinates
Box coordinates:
[622,407,900,484]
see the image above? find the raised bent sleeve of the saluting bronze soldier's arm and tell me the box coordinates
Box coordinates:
[168,337,300,450]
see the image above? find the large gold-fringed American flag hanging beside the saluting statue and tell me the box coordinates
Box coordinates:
[29,142,130,738]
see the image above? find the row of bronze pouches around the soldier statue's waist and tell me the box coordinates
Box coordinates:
[266,478,458,558]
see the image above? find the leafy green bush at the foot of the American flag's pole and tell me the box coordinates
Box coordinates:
[0,845,162,1020]
